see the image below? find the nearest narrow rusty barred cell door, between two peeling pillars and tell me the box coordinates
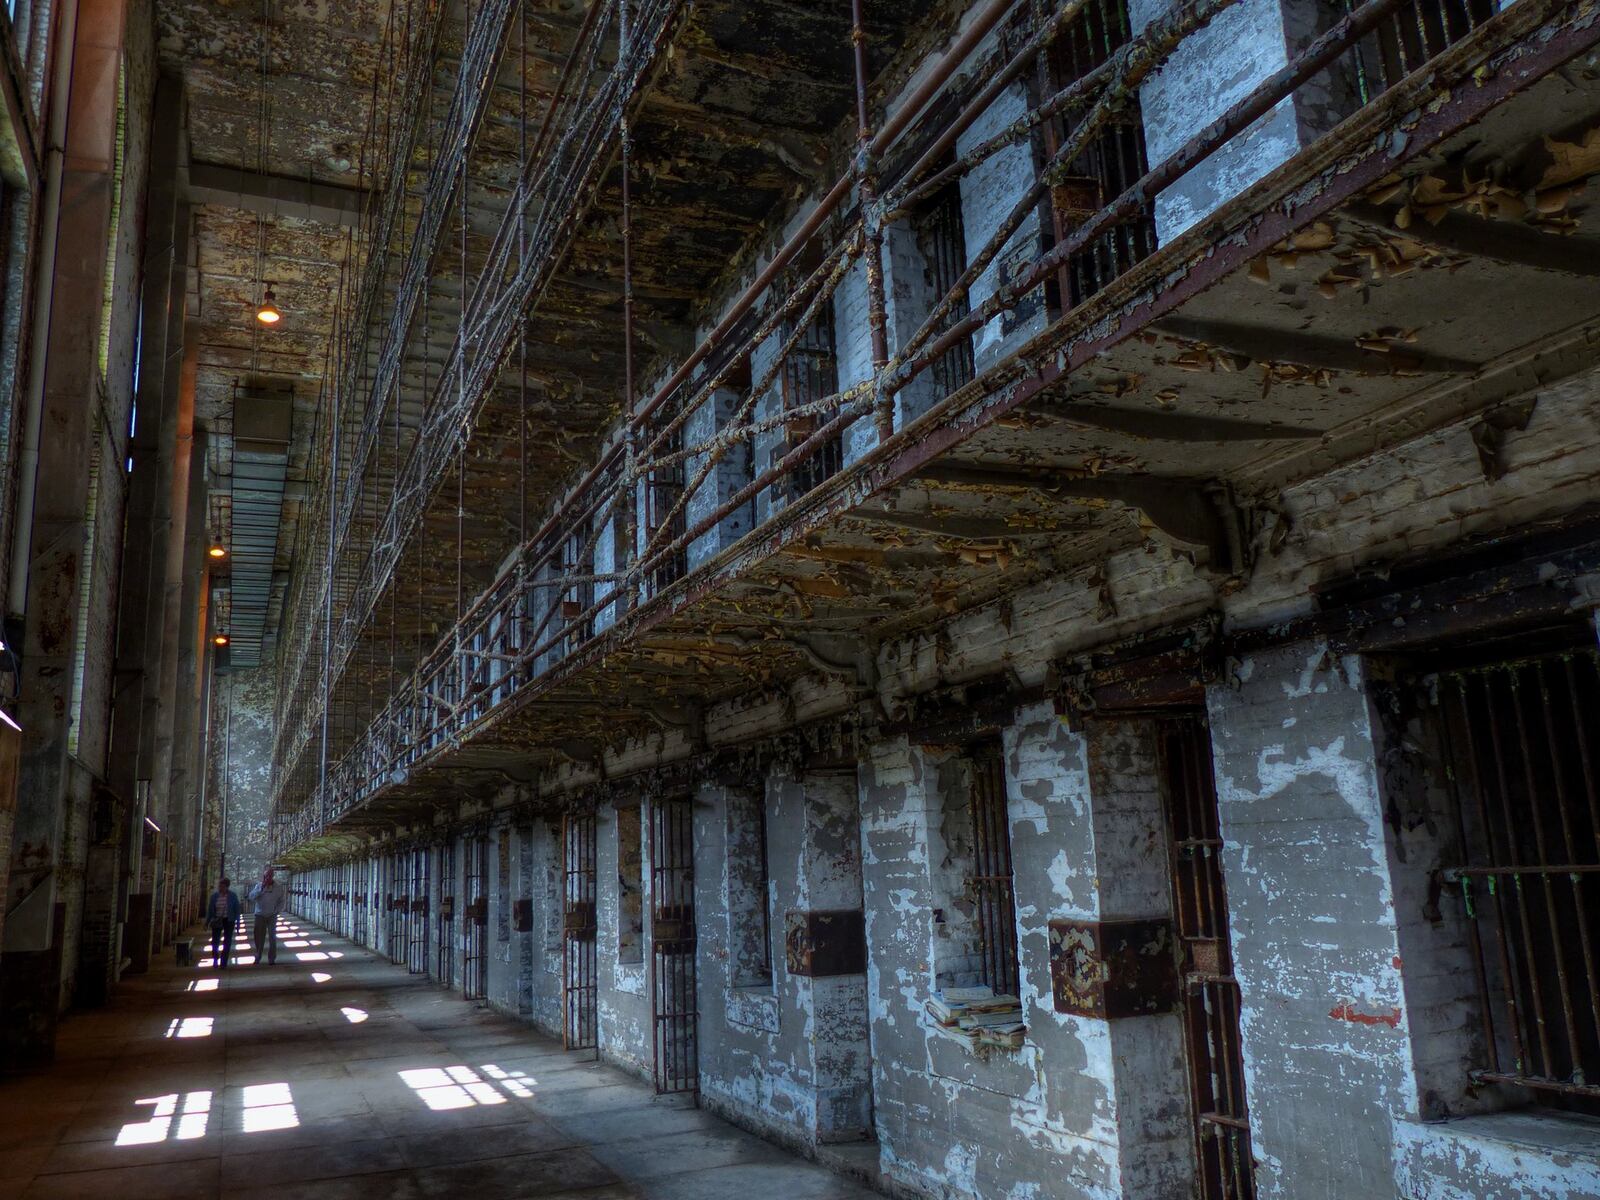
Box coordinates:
[1157,712,1256,1200]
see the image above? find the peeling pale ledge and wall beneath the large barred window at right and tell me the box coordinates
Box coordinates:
[1395,1109,1600,1200]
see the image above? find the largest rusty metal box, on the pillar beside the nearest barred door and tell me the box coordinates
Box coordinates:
[1050,918,1178,1021]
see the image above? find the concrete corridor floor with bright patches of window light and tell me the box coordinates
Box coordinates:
[0,920,877,1200]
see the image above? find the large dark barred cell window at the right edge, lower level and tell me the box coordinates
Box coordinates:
[1438,650,1600,1110]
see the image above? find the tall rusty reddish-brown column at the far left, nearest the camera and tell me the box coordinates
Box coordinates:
[0,0,125,1062]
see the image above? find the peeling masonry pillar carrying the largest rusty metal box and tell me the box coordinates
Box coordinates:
[1005,704,1195,1195]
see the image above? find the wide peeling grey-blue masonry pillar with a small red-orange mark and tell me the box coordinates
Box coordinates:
[1208,642,1419,1200]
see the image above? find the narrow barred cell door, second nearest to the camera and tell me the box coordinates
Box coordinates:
[650,797,699,1093]
